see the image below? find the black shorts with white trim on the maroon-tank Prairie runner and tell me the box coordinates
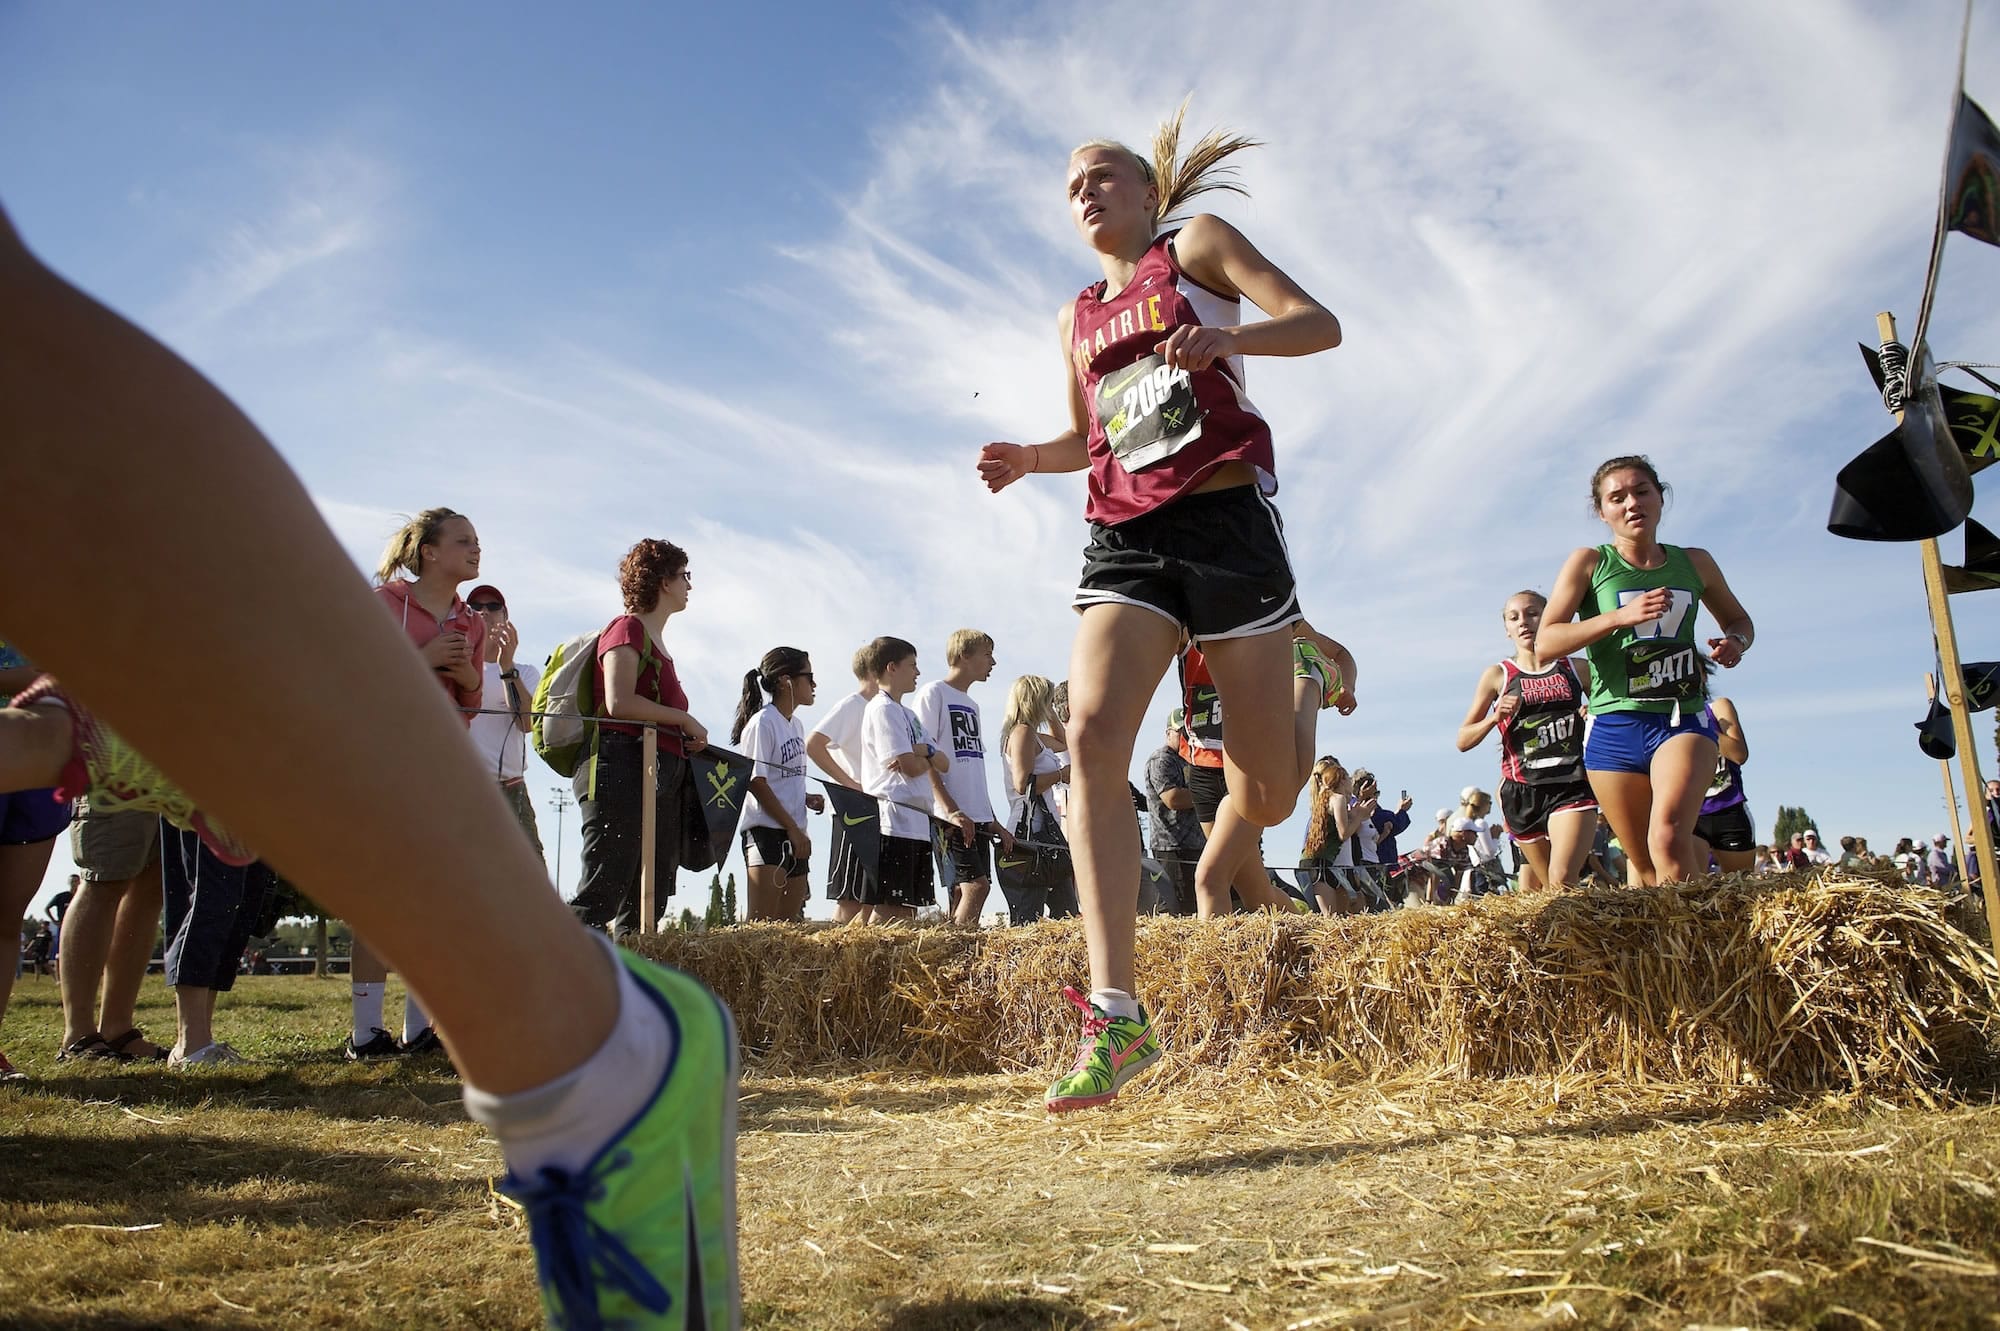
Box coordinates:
[1070,486,1298,642]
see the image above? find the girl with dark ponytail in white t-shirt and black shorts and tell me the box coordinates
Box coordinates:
[730,648,826,919]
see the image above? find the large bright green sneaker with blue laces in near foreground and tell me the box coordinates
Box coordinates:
[500,951,740,1331]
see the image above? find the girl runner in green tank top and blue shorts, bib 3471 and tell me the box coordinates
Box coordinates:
[1534,458,1756,885]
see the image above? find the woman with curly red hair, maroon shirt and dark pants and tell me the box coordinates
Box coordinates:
[570,538,708,937]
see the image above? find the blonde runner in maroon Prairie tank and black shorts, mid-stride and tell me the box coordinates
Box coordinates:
[978,118,1340,1109]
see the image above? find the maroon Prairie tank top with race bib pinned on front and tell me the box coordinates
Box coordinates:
[1070,232,1278,526]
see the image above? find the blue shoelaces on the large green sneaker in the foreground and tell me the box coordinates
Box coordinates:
[516,1151,672,1331]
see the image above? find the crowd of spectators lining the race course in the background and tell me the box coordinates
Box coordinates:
[0,510,2000,1065]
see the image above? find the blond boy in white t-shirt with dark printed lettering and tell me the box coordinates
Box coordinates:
[910,630,1014,925]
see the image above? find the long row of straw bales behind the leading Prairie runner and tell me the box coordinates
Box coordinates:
[644,869,2000,1097]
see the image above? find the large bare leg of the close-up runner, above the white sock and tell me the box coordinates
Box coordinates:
[0,220,618,1093]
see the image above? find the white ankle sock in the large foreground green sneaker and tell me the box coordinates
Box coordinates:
[466,941,674,1179]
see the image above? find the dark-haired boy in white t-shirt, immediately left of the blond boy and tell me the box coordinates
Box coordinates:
[860,638,952,923]
